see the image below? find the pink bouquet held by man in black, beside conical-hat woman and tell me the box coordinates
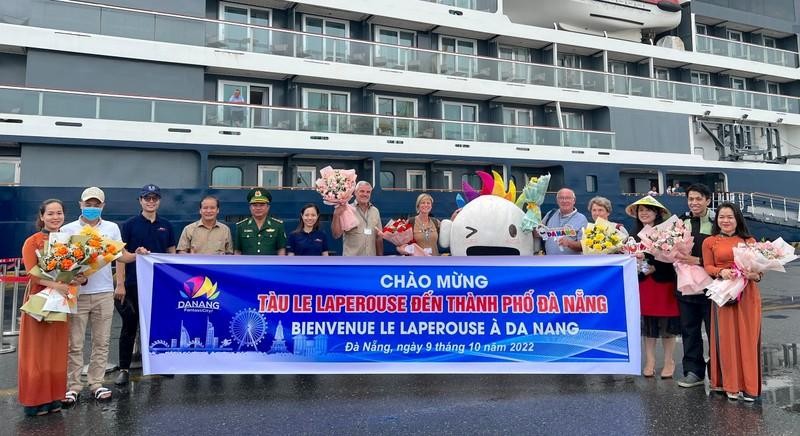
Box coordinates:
[639,215,712,295]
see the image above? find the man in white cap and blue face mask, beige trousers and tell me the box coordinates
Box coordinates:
[61,186,136,404]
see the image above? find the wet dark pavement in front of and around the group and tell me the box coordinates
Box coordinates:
[0,262,800,436]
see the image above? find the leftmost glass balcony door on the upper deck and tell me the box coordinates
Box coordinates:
[219,2,272,53]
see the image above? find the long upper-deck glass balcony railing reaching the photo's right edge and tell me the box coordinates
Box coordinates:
[6,0,800,113]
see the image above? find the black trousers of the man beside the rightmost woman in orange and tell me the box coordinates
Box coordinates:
[678,295,711,379]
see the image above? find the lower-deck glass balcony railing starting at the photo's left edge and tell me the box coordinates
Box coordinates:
[0,86,614,149]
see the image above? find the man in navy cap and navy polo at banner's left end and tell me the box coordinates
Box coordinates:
[114,184,175,385]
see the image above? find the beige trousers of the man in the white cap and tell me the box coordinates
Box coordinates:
[67,292,114,392]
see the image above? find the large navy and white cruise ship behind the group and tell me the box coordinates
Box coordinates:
[0,0,800,257]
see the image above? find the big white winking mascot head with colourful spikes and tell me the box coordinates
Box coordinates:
[439,171,533,256]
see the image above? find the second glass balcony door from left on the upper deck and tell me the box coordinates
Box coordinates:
[303,15,350,62]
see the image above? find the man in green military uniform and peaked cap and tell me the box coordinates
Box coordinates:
[234,188,286,256]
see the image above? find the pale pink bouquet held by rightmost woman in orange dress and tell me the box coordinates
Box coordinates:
[706,238,797,306]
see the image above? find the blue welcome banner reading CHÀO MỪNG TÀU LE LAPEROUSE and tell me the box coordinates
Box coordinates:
[137,254,641,374]
